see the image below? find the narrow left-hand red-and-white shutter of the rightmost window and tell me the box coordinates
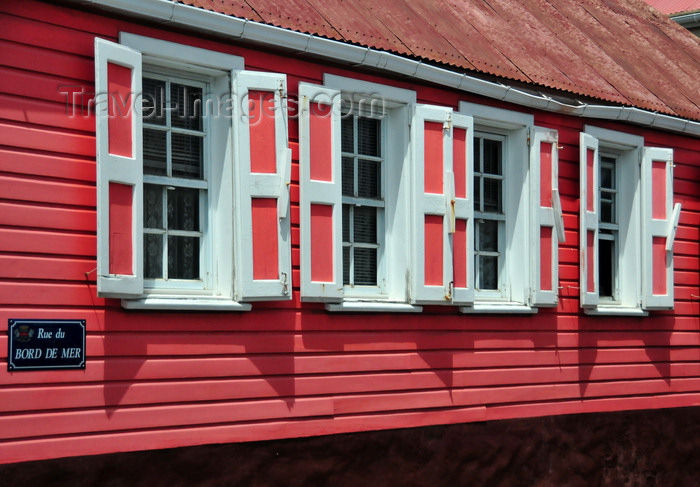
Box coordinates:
[579,133,599,308]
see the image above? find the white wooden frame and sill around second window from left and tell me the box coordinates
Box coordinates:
[301,73,422,312]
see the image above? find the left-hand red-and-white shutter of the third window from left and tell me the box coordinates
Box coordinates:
[448,112,474,306]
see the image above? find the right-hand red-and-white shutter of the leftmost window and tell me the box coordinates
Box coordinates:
[233,71,292,301]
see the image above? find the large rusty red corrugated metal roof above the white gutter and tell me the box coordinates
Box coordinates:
[179,0,700,120]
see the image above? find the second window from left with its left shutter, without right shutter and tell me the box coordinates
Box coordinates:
[299,75,420,311]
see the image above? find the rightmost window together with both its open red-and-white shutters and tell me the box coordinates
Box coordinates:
[580,126,680,315]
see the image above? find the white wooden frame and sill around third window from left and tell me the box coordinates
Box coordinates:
[459,102,537,314]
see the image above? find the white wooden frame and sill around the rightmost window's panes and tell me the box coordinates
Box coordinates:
[581,125,648,316]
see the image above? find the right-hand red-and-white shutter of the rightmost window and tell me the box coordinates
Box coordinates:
[641,147,680,309]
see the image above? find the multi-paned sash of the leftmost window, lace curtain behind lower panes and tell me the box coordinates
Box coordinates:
[143,74,206,289]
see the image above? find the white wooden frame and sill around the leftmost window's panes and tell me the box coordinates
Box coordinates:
[110,32,251,311]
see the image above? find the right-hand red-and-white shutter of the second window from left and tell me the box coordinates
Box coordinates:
[411,105,455,304]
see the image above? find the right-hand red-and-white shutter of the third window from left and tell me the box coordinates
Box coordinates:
[530,127,564,306]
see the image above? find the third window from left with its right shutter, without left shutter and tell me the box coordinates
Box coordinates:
[460,102,564,313]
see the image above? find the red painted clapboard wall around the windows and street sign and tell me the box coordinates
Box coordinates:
[0,0,700,463]
